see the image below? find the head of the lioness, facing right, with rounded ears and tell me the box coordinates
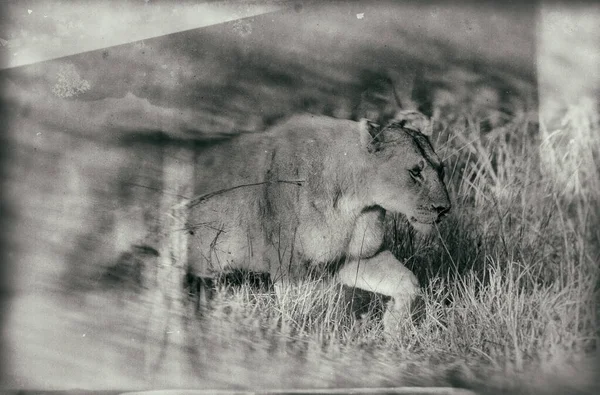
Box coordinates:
[360,112,450,232]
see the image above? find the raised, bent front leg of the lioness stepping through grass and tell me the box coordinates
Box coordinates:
[338,251,420,332]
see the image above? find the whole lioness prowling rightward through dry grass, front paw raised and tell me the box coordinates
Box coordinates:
[187,111,450,326]
